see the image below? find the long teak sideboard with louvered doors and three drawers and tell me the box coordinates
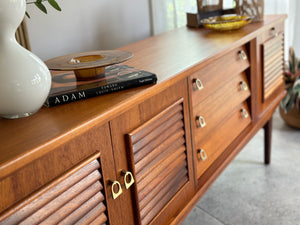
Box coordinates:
[0,15,286,225]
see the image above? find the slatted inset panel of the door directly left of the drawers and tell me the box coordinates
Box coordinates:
[128,100,189,224]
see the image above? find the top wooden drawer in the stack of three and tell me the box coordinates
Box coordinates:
[189,46,249,106]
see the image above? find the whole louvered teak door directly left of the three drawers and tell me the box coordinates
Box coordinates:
[111,80,195,225]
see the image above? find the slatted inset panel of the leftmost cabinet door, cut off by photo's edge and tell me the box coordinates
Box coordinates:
[0,157,107,225]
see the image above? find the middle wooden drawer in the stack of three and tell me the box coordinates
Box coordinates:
[193,72,250,141]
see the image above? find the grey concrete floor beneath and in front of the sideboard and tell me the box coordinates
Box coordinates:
[182,111,300,225]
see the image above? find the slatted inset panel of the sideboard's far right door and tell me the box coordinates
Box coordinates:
[263,34,284,100]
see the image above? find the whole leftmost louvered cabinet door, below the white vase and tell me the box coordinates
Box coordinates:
[0,124,120,224]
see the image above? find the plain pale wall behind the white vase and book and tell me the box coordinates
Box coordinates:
[26,0,151,60]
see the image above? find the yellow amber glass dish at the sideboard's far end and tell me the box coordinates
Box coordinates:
[201,14,252,31]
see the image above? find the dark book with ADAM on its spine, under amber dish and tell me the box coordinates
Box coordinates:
[45,65,157,107]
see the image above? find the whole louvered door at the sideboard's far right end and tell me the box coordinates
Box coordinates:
[250,21,285,117]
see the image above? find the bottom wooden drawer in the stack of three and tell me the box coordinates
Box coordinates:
[195,102,251,178]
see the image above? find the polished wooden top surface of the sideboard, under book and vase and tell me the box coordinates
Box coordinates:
[0,15,285,178]
